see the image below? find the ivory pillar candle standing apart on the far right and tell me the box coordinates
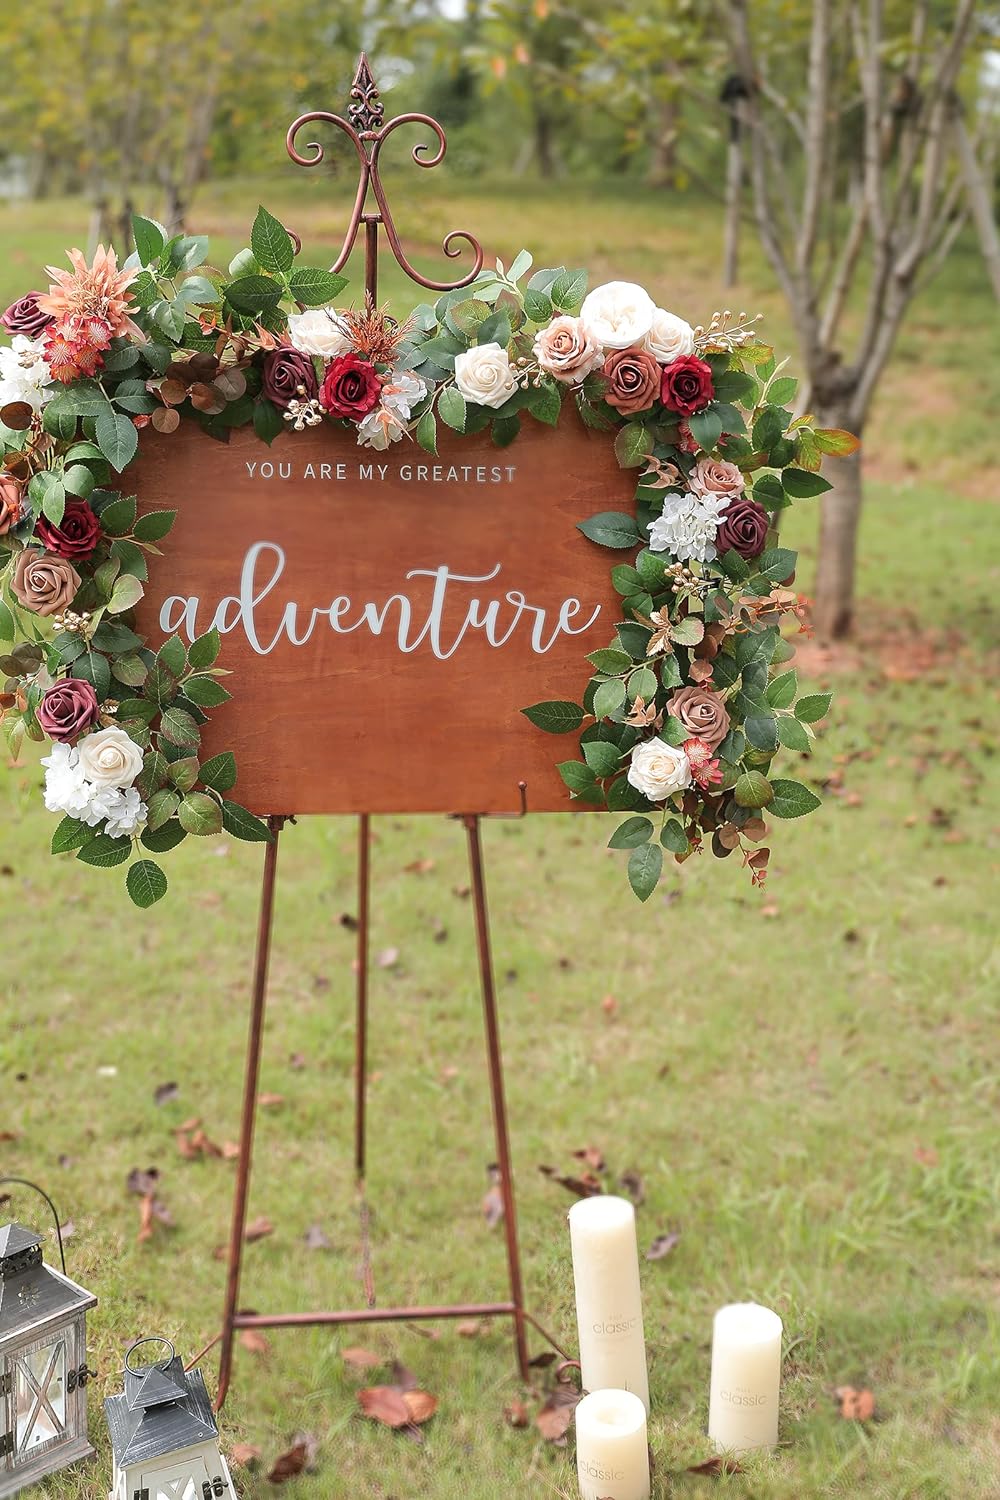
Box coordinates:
[708,1302,781,1454]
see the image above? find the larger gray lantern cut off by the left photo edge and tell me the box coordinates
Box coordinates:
[0,1178,97,1500]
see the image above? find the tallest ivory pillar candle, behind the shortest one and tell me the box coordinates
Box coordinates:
[570,1194,649,1412]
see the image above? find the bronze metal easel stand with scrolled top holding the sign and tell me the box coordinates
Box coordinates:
[209,54,565,1410]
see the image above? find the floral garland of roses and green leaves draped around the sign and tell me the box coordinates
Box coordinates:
[0,209,856,906]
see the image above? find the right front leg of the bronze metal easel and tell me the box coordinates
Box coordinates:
[462,813,529,1380]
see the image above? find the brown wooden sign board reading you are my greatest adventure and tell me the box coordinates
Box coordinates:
[123,410,636,815]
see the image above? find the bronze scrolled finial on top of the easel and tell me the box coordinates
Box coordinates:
[285,53,483,302]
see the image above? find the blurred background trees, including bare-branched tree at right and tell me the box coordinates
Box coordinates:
[0,0,1000,636]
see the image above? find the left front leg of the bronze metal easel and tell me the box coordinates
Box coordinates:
[216,818,285,1412]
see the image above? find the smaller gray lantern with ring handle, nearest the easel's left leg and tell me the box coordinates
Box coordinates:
[103,1338,235,1500]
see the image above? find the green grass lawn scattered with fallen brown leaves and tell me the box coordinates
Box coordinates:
[0,168,1000,1500]
